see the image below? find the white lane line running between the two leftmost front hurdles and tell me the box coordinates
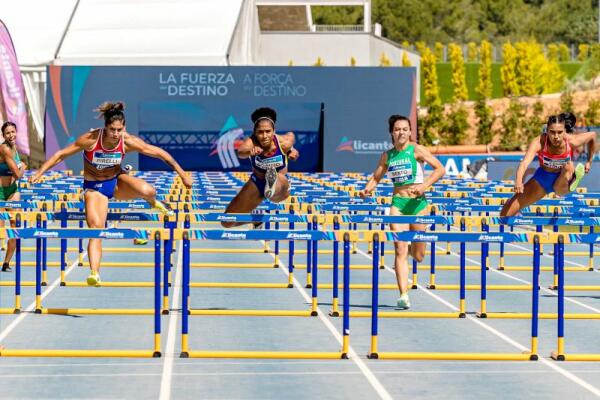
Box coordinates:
[159,241,183,400]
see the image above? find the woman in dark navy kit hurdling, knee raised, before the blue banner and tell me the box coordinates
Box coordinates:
[221,107,299,228]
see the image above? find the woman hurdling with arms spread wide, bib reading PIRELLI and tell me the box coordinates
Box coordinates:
[30,102,192,286]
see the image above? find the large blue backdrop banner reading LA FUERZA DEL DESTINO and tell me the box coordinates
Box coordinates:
[45,66,416,172]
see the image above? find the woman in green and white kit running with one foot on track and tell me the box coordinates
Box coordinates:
[361,115,446,309]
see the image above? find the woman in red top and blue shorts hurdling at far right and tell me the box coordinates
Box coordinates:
[500,113,596,217]
